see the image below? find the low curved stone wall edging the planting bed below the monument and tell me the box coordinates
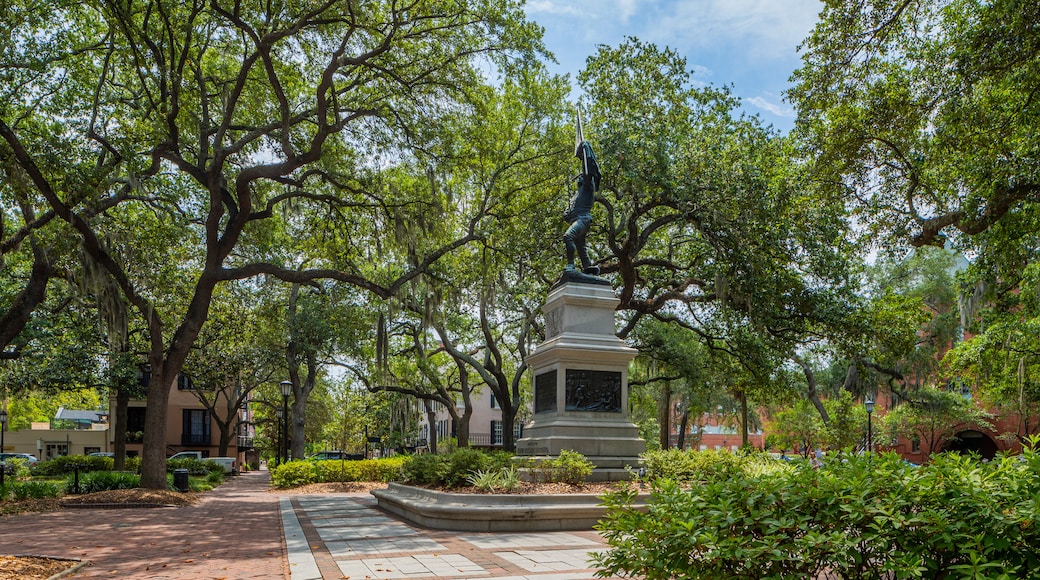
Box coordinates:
[371,483,648,532]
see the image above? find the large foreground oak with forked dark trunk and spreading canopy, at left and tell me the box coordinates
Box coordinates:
[0,0,538,487]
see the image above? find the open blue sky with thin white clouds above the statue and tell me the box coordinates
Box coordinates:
[526,0,823,132]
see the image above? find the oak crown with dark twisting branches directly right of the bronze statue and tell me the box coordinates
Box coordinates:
[578,39,857,430]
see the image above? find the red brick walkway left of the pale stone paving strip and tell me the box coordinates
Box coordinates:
[0,471,287,580]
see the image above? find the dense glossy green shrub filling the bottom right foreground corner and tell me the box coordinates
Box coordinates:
[597,450,1040,580]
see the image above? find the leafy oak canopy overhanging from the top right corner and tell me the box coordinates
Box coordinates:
[790,0,1040,252]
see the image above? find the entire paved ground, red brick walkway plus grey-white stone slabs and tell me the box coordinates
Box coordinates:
[0,471,605,580]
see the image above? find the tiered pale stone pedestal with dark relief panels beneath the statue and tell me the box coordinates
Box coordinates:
[517,282,646,480]
